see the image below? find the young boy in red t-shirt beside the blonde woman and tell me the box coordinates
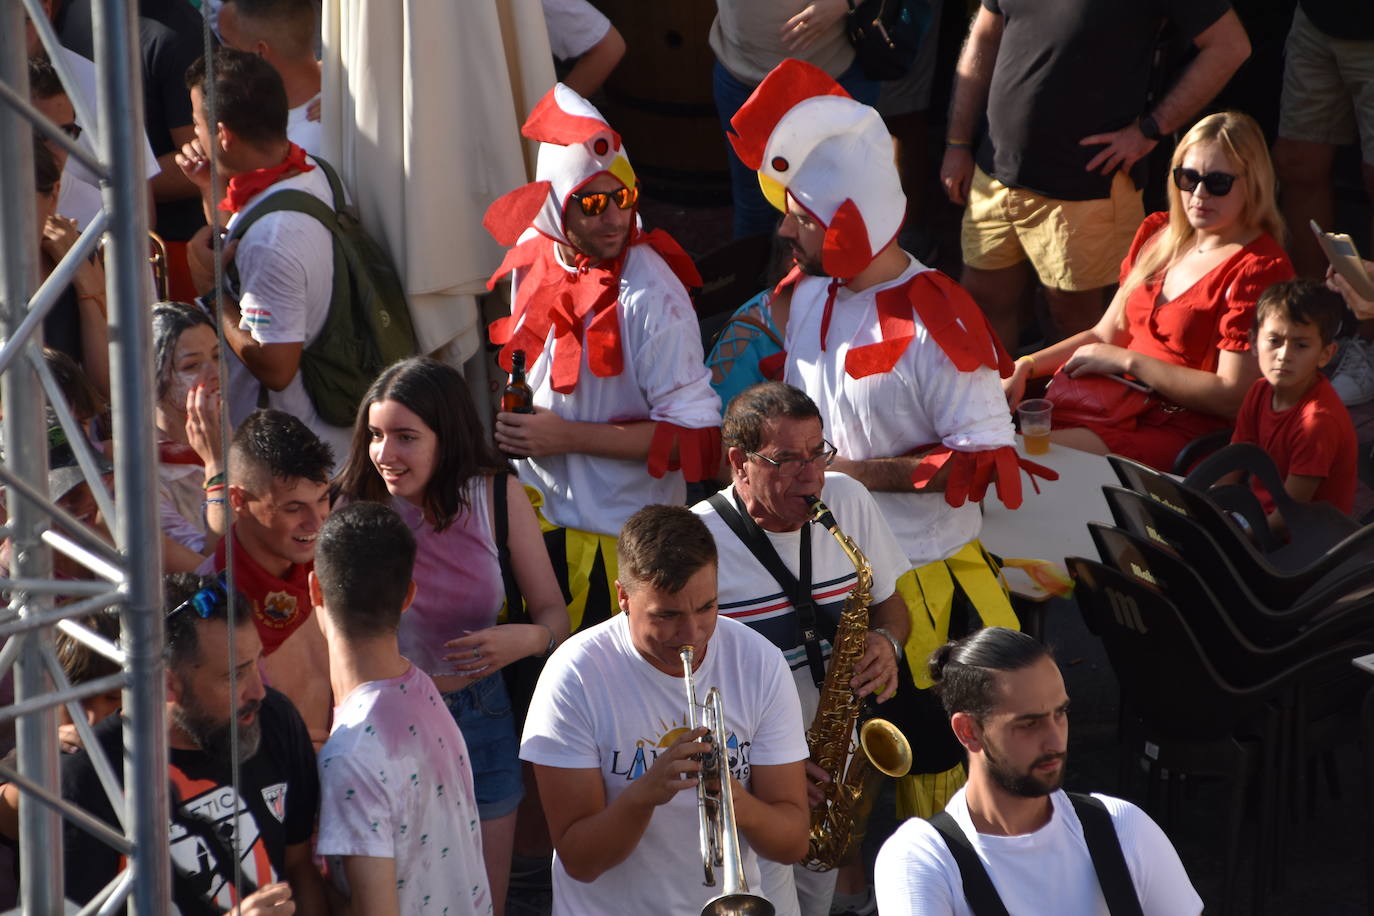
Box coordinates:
[1231,280,1358,533]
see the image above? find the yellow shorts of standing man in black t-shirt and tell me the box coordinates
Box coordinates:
[960,169,1145,291]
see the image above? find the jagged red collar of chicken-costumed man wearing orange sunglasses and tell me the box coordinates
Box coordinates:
[486,229,701,394]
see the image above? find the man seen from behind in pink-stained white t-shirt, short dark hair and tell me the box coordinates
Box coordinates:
[311,503,492,916]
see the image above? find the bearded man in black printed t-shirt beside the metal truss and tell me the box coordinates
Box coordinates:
[62,573,328,916]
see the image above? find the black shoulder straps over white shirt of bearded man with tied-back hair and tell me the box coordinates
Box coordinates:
[929,792,1145,916]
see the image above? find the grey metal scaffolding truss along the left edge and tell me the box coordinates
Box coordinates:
[0,0,170,916]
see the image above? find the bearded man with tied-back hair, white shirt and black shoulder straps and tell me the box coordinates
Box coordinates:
[874,628,1202,916]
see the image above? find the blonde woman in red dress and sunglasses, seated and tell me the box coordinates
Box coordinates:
[1003,111,1293,470]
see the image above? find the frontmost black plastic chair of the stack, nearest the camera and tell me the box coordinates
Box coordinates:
[1065,556,1369,913]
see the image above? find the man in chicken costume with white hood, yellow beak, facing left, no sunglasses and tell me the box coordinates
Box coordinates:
[731,60,1054,816]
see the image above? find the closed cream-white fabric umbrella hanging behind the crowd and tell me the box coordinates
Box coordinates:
[322,0,555,363]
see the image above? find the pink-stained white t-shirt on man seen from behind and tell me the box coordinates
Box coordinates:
[315,665,492,916]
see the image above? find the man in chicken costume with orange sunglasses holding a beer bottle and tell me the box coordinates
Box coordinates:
[484,84,720,632]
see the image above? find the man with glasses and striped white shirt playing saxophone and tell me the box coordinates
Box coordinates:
[692,382,910,916]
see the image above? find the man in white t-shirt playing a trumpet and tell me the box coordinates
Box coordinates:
[521,505,809,916]
